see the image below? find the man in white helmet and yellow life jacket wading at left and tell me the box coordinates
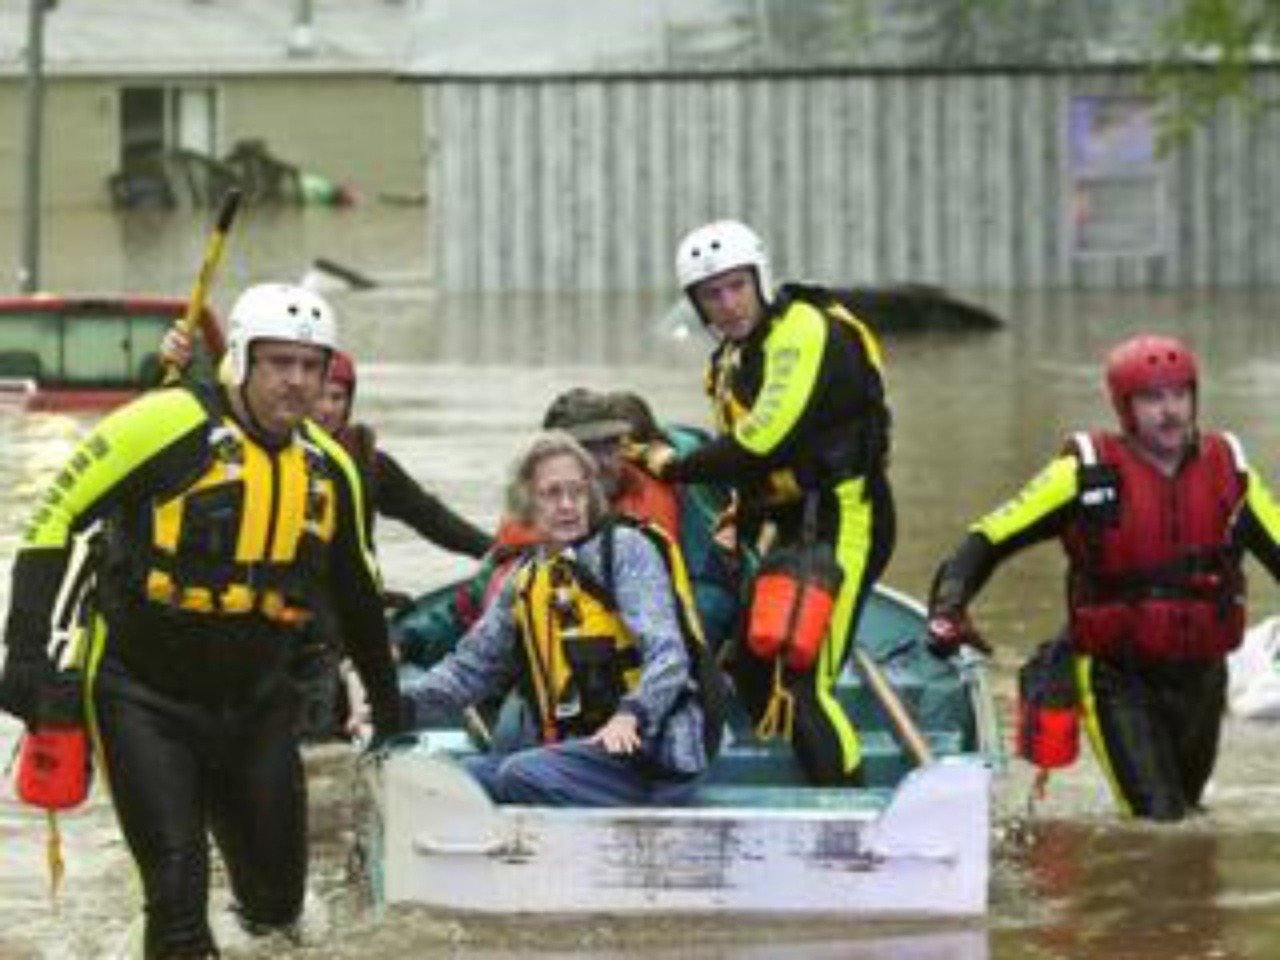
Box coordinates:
[0,284,399,957]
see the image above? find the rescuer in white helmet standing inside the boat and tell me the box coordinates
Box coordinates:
[634,220,895,785]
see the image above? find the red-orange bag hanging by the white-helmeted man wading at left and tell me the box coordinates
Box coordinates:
[17,672,90,810]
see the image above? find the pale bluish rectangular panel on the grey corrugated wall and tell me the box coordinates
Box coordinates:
[1065,96,1169,259]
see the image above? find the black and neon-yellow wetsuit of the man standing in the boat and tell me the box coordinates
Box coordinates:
[666,285,895,785]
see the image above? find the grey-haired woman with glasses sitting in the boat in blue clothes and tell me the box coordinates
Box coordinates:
[403,430,708,806]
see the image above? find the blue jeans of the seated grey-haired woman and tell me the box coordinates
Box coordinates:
[466,740,698,806]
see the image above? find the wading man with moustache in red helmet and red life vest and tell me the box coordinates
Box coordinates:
[929,335,1280,820]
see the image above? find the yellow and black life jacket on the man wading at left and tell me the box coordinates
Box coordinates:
[132,411,337,627]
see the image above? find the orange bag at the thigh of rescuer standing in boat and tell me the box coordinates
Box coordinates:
[746,544,845,671]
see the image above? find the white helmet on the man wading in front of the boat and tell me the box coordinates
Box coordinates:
[227,283,338,387]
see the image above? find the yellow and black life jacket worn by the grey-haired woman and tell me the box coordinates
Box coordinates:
[516,517,727,758]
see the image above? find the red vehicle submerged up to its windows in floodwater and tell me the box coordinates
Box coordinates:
[0,293,220,411]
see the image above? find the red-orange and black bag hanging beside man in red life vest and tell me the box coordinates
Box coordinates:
[1018,639,1080,771]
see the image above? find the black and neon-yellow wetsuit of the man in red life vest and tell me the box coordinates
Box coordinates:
[929,435,1280,820]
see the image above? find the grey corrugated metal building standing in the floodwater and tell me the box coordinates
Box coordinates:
[411,0,1280,291]
